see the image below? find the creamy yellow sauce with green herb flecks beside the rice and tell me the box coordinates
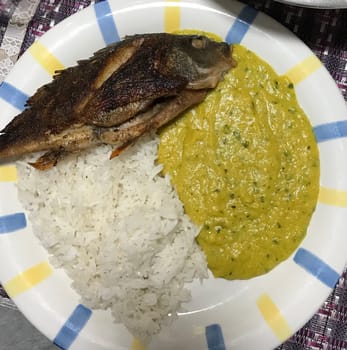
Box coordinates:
[158,45,319,279]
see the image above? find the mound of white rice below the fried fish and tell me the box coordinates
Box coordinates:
[18,136,207,342]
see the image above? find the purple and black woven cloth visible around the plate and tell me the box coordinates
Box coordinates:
[0,0,347,350]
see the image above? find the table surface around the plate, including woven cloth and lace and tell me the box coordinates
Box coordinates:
[0,0,347,350]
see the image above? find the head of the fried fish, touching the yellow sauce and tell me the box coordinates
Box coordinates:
[166,35,233,90]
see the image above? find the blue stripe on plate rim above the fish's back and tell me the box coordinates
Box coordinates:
[94,1,120,45]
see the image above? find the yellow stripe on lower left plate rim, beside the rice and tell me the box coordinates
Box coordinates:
[4,262,53,298]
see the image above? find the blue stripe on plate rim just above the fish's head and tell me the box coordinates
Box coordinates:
[225,6,258,44]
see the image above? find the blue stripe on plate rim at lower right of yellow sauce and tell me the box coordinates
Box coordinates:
[294,248,340,288]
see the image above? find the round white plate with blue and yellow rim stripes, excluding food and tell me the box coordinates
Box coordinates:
[0,0,347,350]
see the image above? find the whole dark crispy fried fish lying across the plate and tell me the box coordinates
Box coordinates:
[0,33,233,170]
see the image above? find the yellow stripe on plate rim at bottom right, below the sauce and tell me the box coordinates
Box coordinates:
[257,294,293,341]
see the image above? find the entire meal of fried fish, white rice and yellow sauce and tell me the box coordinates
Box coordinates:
[0,31,319,342]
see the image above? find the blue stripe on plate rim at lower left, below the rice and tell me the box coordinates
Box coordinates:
[53,304,92,350]
